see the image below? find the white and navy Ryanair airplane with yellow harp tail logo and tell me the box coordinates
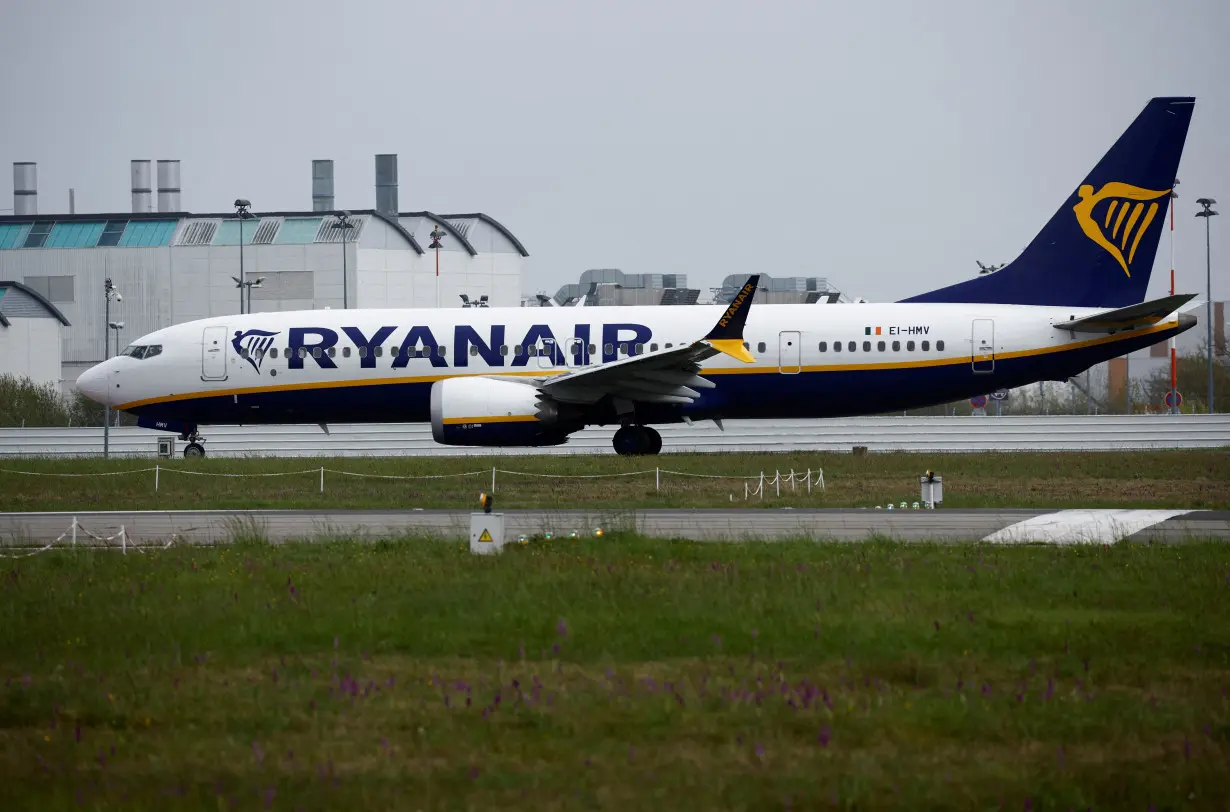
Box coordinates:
[76,97,1196,456]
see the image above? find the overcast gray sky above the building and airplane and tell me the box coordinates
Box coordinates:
[0,0,1230,301]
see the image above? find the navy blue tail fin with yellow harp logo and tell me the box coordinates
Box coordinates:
[903,97,1196,308]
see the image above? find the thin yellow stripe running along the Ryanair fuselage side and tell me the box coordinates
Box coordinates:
[113,320,1178,410]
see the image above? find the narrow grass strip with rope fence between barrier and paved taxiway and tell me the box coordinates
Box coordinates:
[0,450,1230,511]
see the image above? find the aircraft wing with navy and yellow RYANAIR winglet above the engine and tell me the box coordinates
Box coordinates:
[539,274,760,404]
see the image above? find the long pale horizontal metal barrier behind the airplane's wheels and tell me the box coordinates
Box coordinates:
[0,415,1230,458]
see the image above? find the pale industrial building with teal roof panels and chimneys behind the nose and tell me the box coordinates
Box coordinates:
[0,155,529,390]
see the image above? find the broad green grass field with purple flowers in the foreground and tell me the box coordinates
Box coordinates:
[0,538,1230,810]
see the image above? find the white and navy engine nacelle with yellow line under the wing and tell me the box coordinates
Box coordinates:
[432,378,582,445]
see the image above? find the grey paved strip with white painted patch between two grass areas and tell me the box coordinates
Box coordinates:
[0,508,1230,546]
